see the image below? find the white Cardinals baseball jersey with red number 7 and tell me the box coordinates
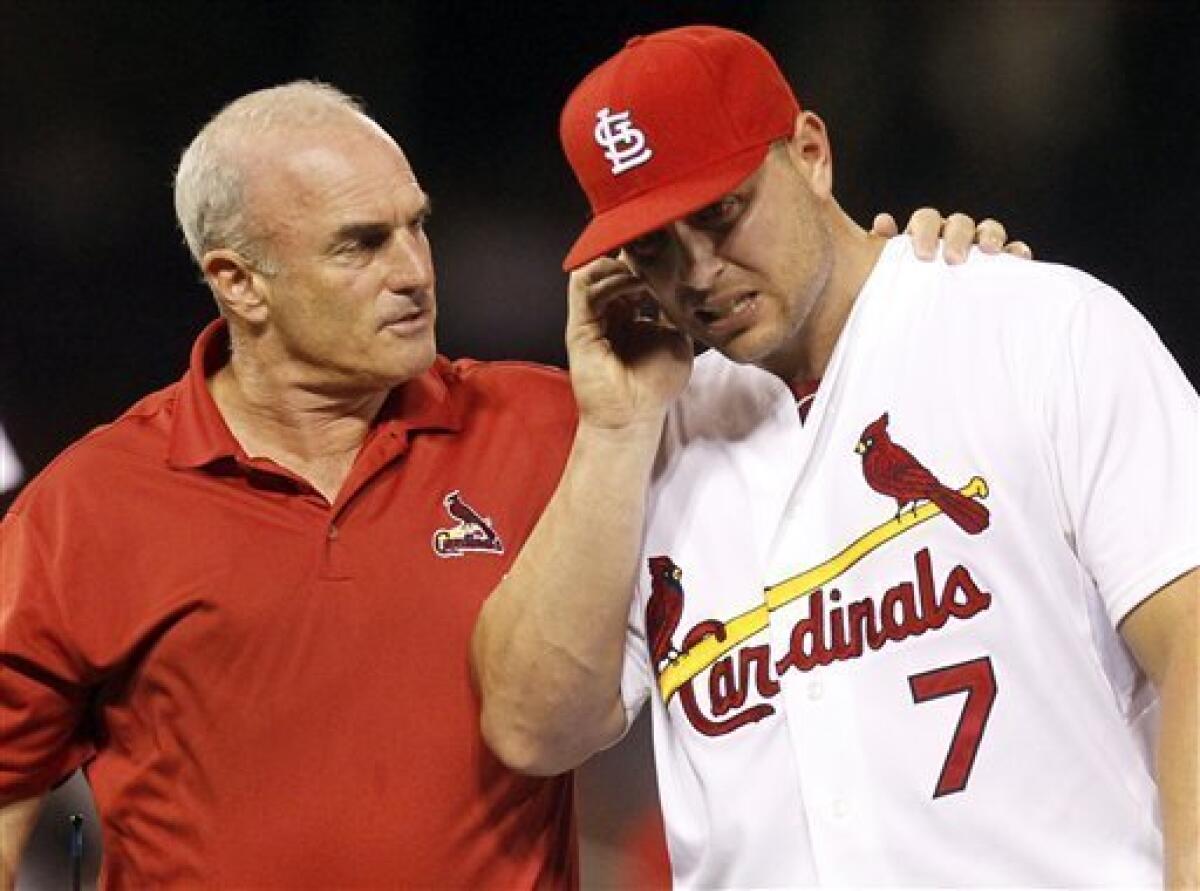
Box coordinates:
[623,239,1200,887]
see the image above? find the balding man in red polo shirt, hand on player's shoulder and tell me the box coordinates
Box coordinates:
[0,78,1002,889]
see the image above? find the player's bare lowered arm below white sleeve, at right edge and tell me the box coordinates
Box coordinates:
[1121,569,1200,889]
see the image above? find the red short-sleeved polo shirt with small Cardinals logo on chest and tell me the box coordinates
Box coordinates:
[0,323,576,889]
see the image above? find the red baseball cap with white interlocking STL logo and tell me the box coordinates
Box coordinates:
[558,25,800,270]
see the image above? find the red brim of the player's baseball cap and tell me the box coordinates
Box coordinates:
[563,142,770,271]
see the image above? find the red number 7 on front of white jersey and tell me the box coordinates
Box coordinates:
[908,656,996,799]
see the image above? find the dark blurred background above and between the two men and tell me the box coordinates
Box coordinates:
[0,0,1200,883]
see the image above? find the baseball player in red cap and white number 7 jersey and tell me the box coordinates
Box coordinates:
[474,28,1200,887]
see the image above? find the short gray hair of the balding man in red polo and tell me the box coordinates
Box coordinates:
[175,80,364,274]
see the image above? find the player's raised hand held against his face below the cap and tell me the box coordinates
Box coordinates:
[566,257,692,427]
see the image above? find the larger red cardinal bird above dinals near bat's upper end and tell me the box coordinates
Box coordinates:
[854,412,991,536]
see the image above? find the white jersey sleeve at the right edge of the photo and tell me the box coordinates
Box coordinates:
[1048,286,1200,626]
